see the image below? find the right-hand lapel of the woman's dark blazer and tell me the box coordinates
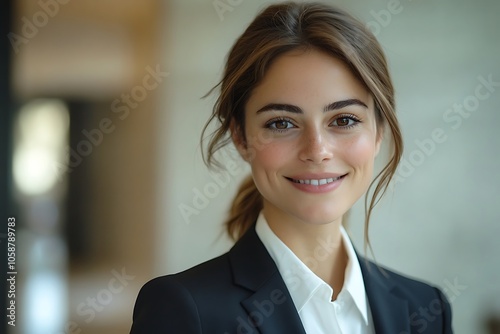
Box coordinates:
[359,257,410,333]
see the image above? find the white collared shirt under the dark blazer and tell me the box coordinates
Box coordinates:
[255,212,375,334]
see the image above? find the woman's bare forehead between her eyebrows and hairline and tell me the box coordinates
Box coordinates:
[248,49,371,107]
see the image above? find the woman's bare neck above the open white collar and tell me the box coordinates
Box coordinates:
[264,211,348,299]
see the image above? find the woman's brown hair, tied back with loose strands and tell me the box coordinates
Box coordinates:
[202,2,403,246]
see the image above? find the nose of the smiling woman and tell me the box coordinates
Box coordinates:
[299,128,333,164]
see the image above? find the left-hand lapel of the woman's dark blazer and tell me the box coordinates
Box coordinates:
[229,226,306,334]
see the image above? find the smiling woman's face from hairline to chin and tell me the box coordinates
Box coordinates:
[233,50,381,224]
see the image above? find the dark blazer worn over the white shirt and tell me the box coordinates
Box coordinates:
[131,224,452,334]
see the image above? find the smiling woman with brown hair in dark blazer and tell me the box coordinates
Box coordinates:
[131,2,452,334]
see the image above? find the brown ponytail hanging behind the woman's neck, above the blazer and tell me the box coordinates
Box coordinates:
[226,175,263,240]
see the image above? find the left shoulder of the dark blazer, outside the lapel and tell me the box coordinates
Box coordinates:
[131,253,262,334]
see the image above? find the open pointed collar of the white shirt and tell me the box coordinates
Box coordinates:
[255,212,368,324]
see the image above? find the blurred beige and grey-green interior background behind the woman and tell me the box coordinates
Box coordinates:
[0,0,500,334]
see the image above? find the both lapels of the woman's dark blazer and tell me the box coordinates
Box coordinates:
[229,225,410,334]
